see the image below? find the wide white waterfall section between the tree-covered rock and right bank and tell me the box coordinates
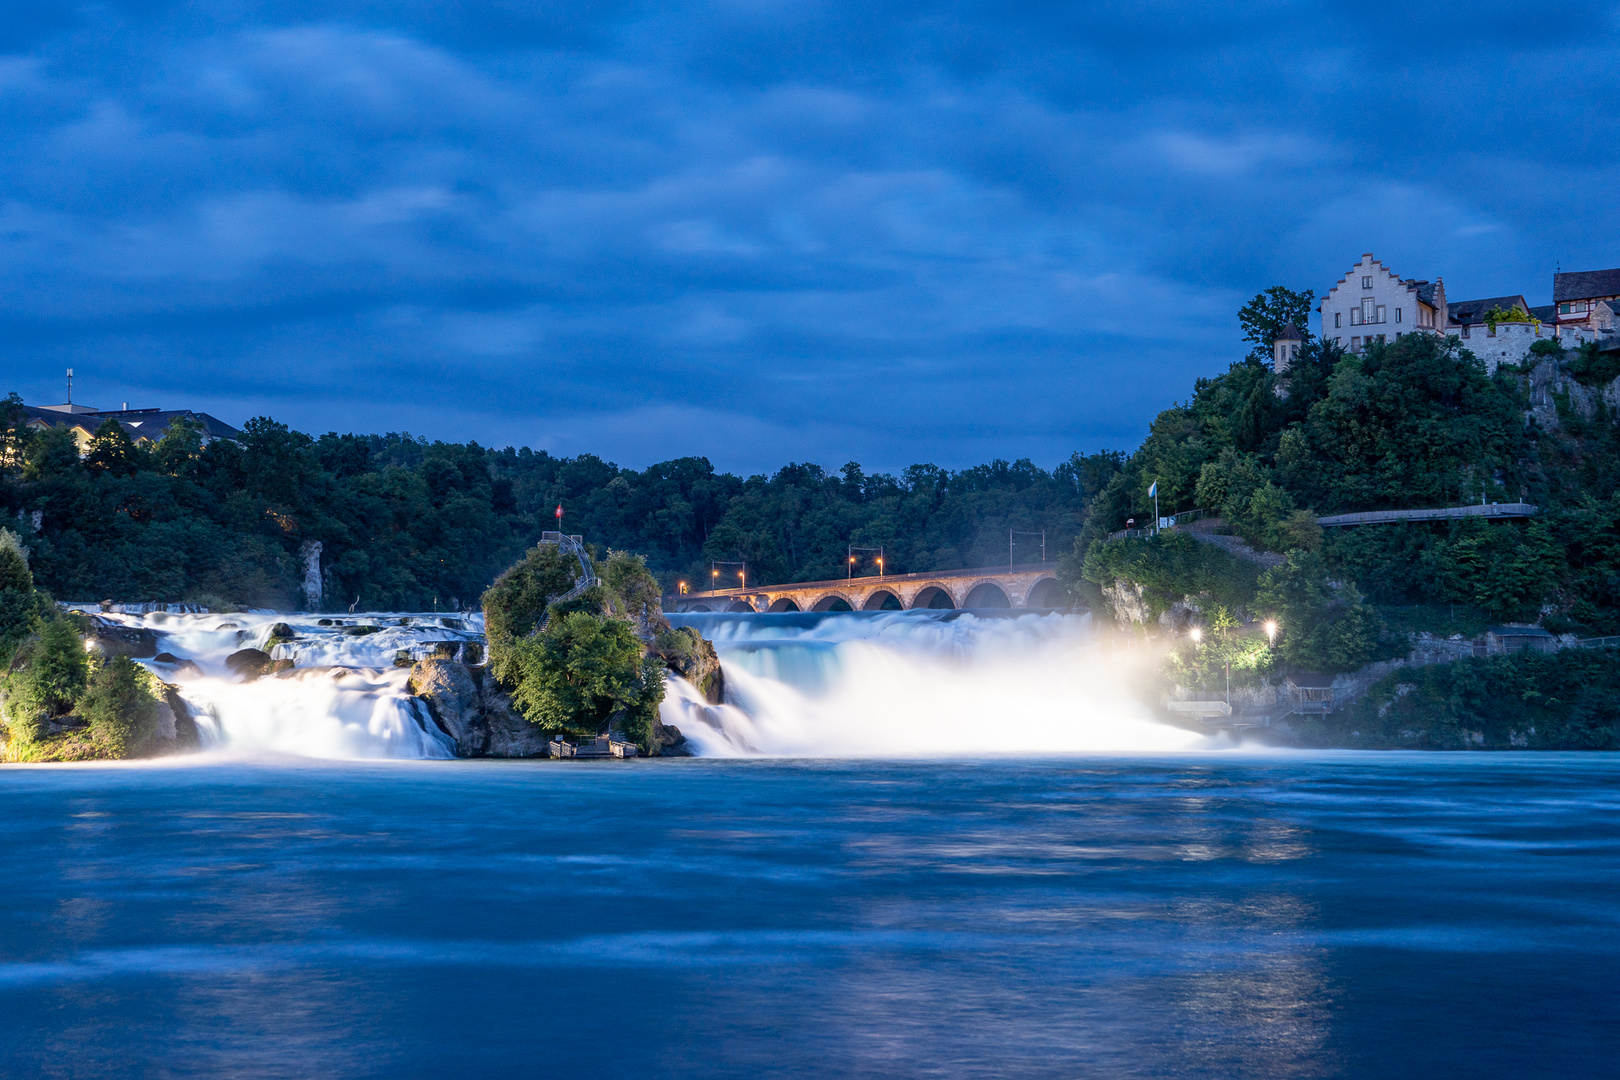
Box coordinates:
[663,610,1212,758]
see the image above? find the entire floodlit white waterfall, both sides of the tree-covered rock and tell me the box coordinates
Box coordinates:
[85,610,1212,758]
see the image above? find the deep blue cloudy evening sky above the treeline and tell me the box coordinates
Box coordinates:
[0,0,1620,471]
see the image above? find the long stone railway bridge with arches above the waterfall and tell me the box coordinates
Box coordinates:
[664,562,1059,612]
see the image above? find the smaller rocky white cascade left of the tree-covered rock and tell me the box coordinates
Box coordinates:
[99,612,483,758]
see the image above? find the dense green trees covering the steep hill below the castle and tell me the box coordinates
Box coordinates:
[1066,288,1620,670]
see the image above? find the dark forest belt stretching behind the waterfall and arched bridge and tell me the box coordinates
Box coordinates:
[0,395,1123,610]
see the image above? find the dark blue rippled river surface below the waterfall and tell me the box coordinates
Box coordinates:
[0,753,1620,1080]
